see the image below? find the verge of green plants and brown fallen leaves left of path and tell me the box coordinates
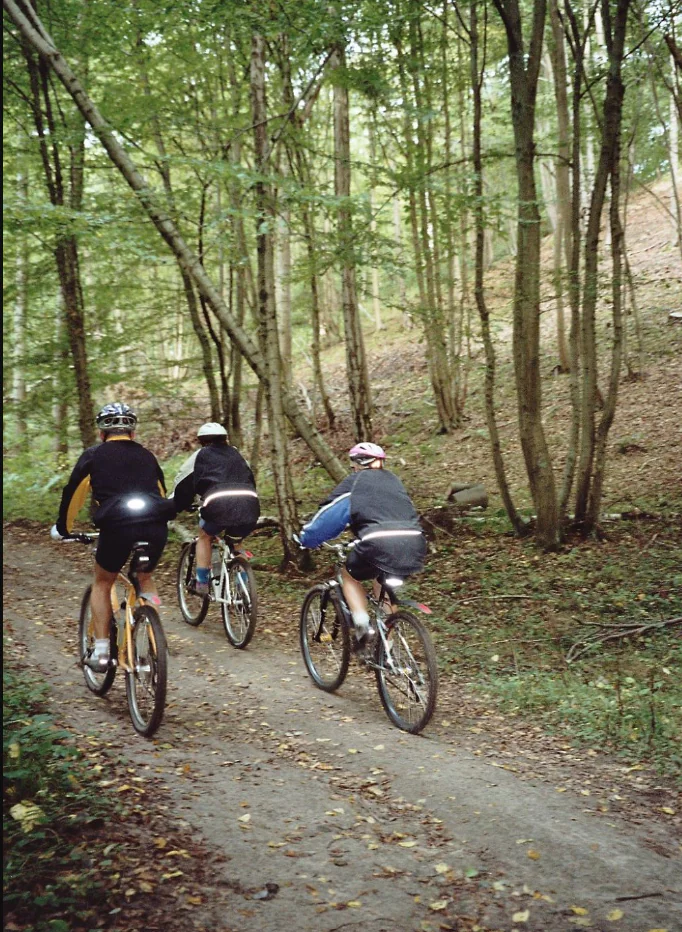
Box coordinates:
[2,644,231,932]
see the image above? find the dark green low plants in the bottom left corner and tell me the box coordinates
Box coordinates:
[2,650,113,932]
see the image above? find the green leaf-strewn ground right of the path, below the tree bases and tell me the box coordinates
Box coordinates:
[243,519,682,774]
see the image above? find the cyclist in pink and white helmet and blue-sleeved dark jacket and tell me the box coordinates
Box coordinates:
[300,442,426,640]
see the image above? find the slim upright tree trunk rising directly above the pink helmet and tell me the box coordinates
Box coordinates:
[330,45,372,440]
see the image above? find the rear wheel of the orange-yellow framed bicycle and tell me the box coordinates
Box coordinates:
[126,605,168,738]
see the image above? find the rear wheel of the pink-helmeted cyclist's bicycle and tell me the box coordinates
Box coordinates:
[374,612,438,735]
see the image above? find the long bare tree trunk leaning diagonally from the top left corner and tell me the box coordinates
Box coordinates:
[3,0,346,482]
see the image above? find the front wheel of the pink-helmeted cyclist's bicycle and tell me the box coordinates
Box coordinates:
[299,584,350,693]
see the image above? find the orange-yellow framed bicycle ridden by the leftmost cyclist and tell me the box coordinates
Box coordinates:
[64,534,168,738]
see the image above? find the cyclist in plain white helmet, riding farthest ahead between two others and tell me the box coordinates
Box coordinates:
[171,422,260,595]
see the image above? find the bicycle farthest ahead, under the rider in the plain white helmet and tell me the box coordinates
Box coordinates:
[176,533,258,650]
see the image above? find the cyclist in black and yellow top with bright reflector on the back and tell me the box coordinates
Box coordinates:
[50,402,175,672]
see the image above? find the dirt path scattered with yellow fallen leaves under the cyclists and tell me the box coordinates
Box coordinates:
[4,531,682,932]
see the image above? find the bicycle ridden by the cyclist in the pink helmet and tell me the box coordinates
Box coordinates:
[299,544,438,734]
